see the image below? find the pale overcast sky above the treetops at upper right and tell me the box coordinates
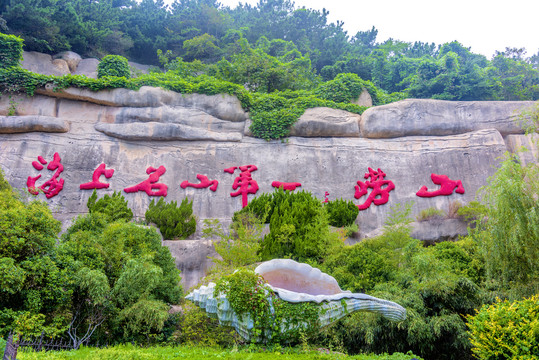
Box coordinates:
[207,0,539,59]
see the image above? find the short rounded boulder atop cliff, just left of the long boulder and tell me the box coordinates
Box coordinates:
[290,107,361,137]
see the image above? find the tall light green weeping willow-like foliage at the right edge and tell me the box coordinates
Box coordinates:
[474,155,539,299]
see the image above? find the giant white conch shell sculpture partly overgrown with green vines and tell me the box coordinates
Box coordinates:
[185,259,406,340]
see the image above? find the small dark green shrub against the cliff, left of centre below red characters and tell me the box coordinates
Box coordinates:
[145,197,196,239]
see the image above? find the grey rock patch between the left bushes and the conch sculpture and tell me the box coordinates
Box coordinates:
[163,240,219,292]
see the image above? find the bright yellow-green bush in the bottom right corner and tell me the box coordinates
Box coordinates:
[467,295,539,360]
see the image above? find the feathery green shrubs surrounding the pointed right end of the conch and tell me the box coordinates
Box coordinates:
[316,205,485,359]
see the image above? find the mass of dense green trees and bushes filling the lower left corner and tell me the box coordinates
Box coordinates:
[0,174,182,348]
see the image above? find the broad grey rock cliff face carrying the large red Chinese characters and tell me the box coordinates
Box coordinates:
[0,70,538,286]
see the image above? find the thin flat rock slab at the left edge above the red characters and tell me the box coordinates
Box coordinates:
[0,115,69,134]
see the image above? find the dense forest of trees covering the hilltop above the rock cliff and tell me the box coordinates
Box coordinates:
[0,0,539,103]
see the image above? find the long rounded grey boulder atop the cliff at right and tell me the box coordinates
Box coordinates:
[361,99,534,139]
